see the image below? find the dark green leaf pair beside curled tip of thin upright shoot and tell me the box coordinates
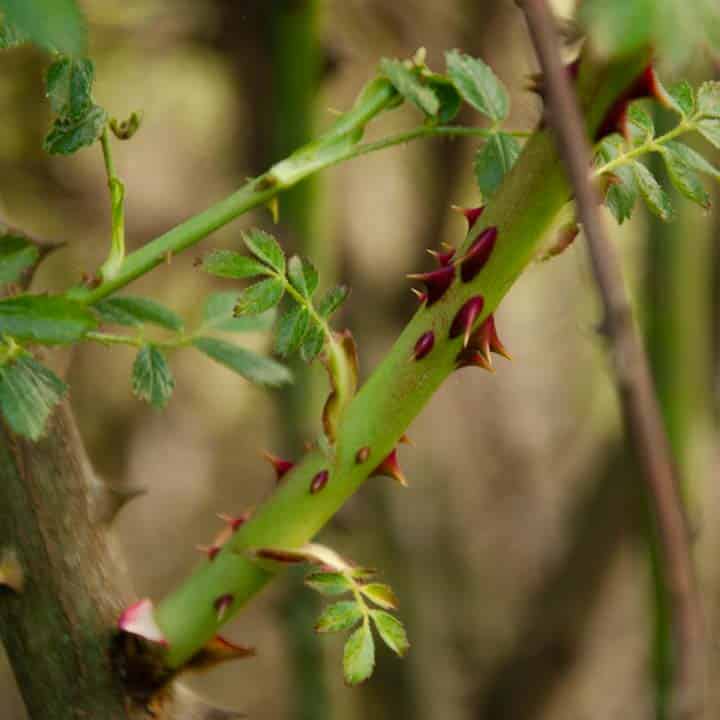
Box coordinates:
[44,57,107,155]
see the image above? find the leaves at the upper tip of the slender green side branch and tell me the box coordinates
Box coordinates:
[380,50,521,197]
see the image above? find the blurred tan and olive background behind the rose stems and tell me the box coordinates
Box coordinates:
[0,0,720,720]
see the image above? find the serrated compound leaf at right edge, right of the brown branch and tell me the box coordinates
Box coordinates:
[595,81,720,223]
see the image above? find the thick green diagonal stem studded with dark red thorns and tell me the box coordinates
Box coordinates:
[155,52,646,667]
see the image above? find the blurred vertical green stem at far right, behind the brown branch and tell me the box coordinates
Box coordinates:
[645,160,713,720]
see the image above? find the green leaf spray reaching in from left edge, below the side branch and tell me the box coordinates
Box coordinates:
[0,228,291,440]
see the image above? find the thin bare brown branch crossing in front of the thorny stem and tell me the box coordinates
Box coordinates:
[519,0,705,718]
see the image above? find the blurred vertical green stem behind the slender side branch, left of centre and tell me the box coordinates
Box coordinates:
[269,0,328,720]
